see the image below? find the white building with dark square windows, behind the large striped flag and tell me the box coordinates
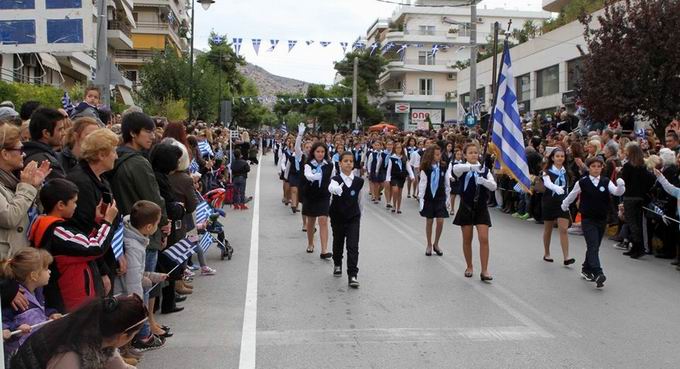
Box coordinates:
[457,0,603,118]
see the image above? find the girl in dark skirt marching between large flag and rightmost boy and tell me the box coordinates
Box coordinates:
[542,147,576,265]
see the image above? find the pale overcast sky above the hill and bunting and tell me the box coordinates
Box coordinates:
[195,0,541,84]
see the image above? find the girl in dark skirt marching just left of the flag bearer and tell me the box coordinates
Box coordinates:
[418,145,451,256]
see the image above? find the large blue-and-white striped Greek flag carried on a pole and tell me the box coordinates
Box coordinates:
[491,43,531,192]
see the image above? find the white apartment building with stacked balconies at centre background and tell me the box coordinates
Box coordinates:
[366,0,550,129]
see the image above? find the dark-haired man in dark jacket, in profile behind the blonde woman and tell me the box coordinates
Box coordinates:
[24,108,66,180]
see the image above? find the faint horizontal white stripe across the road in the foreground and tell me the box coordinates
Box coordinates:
[258,326,552,346]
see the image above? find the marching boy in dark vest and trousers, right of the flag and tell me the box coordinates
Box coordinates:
[562,156,626,288]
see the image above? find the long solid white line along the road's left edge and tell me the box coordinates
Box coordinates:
[238,151,262,369]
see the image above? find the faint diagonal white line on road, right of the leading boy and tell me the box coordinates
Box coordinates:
[367,207,553,338]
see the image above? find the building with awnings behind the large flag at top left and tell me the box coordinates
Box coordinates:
[0,0,135,105]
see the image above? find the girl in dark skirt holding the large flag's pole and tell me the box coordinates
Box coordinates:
[453,143,497,282]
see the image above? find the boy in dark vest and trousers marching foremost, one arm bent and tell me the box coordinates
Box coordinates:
[328,152,364,288]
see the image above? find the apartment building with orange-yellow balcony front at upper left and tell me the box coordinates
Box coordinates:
[114,0,191,85]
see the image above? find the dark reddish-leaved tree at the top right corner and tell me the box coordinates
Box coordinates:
[579,0,680,136]
